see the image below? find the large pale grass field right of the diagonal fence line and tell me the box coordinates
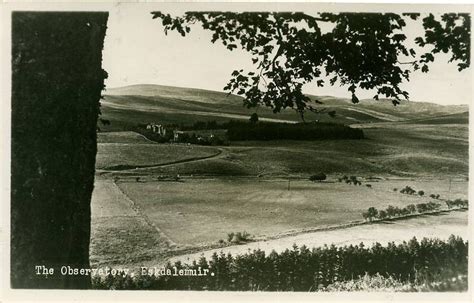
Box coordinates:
[118,178,467,246]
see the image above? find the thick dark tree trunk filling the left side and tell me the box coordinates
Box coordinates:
[11,12,108,288]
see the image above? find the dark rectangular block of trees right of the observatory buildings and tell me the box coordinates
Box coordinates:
[227,122,364,141]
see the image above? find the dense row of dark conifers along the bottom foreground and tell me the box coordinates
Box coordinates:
[93,236,468,291]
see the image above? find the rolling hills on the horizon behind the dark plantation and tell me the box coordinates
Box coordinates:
[99,84,468,131]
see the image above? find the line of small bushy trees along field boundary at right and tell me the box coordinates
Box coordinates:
[362,202,441,221]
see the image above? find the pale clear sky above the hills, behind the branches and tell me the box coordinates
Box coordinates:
[103,6,472,105]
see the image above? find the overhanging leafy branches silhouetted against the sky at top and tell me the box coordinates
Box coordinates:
[152,12,470,117]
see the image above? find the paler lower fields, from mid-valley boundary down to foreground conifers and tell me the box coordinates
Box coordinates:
[91,177,468,268]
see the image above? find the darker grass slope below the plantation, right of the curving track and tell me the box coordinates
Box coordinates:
[114,124,469,178]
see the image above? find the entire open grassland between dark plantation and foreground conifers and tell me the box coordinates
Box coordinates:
[91,123,469,266]
